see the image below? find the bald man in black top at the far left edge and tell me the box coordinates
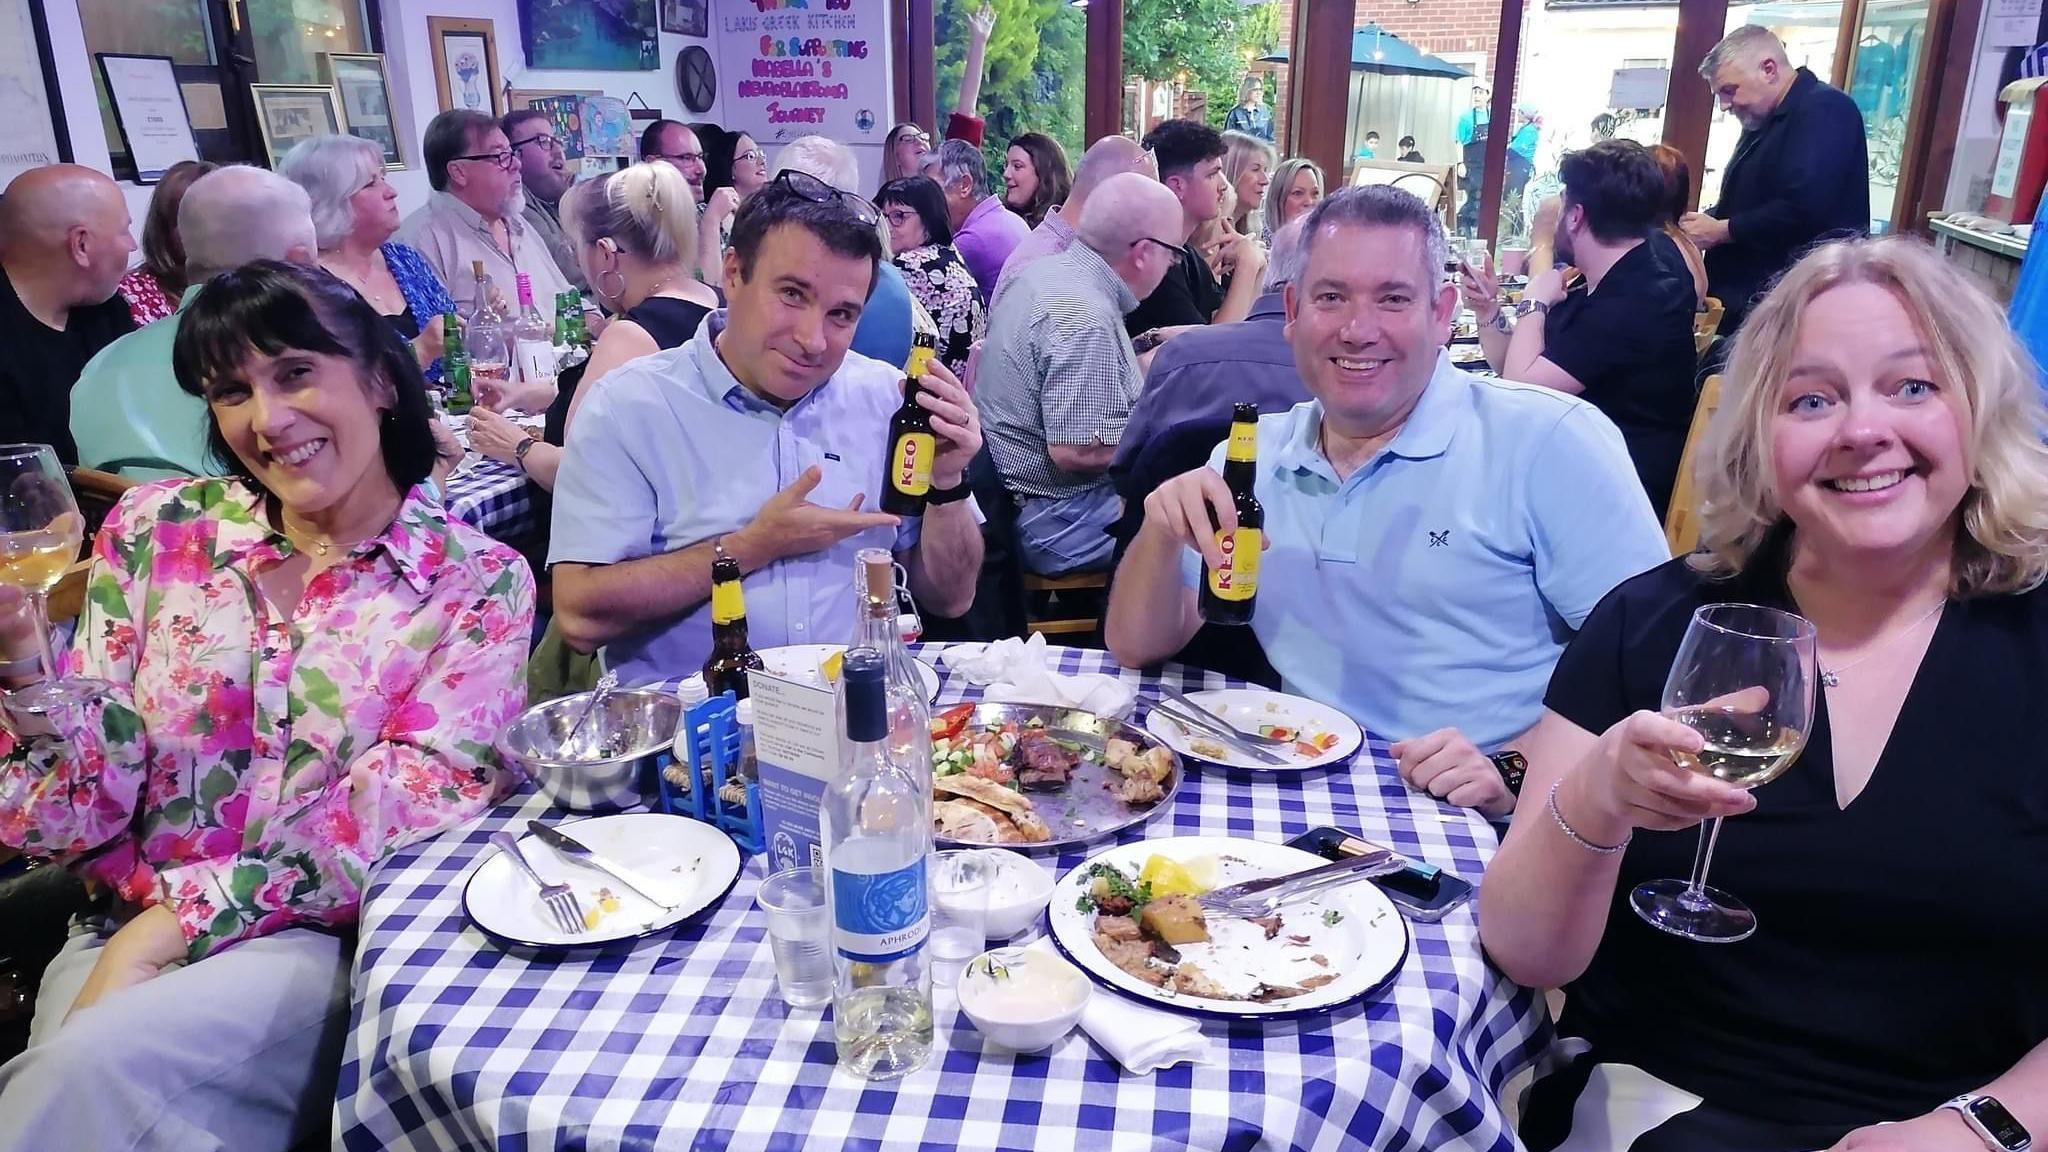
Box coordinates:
[0,164,135,463]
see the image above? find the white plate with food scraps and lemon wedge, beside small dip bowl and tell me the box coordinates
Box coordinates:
[1049,836,1409,1019]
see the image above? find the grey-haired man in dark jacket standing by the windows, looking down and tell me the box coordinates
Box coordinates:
[1679,25,1870,334]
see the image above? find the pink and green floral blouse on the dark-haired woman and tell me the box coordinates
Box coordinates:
[0,471,532,959]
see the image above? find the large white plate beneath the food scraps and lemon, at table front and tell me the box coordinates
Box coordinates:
[1047,836,1409,1019]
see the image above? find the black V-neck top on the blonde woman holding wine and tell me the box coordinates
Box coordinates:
[1544,533,2048,1152]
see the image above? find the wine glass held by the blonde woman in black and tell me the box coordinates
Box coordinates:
[1628,605,1819,943]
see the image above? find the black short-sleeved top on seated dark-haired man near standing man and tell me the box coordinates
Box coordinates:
[1542,232,1698,521]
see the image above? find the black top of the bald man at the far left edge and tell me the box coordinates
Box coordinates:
[0,269,135,463]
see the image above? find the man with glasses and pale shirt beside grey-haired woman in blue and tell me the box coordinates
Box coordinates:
[399,109,569,324]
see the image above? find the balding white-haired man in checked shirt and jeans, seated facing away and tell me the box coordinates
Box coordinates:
[975,172,1184,576]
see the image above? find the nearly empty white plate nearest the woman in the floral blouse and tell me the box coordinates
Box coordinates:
[463,812,739,947]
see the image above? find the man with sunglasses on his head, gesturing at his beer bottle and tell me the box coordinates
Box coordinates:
[549,172,981,685]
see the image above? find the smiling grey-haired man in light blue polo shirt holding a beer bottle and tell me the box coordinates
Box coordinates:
[1108,187,1669,816]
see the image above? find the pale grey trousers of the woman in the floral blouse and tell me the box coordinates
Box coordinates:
[0,916,352,1152]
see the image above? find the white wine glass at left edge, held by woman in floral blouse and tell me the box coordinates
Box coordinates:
[0,445,106,715]
